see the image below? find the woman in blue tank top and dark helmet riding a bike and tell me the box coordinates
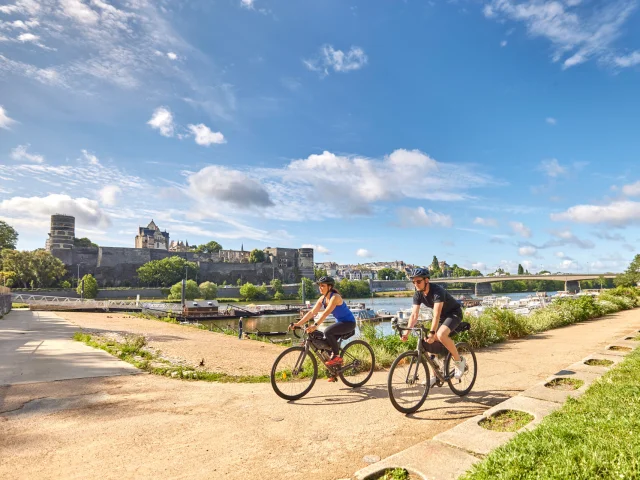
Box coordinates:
[294,277,356,382]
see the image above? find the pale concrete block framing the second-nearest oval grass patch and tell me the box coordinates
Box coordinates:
[434,395,560,455]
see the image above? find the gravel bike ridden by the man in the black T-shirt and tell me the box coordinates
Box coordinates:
[387,322,478,413]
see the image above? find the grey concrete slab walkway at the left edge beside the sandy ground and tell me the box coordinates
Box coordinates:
[0,310,141,386]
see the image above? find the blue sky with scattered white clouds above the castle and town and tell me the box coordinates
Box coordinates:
[0,0,640,273]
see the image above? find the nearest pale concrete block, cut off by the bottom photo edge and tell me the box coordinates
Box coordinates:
[354,440,479,480]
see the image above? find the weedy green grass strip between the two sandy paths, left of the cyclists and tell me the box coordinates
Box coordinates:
[73,332,269,383]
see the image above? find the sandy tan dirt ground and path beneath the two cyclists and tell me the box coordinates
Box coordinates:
[0,310,640,480]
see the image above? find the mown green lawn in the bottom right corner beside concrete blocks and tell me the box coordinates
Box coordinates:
[461,350,640,480]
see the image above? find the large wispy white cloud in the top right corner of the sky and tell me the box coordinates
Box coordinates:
[484,0,636,68]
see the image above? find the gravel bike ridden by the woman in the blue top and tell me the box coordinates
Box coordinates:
[271,323,375,400]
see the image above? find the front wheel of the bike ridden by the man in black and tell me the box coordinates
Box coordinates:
[387,351,430,413]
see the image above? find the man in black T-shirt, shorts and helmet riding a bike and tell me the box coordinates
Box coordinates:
[402,268,466,378]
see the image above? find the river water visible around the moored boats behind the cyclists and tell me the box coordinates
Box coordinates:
[200,292,557,335]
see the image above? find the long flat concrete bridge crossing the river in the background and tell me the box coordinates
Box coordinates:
[371,273,617,295]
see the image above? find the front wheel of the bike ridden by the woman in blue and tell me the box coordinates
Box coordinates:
[271,347,318,400]
